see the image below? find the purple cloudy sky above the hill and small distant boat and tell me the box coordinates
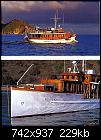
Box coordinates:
[1,1,100,24]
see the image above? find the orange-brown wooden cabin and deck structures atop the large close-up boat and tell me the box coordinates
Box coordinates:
[15,61,100,99]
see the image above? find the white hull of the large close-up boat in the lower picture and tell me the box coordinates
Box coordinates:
[11,89,100,117]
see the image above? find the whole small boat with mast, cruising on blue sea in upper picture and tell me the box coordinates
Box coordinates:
[25,11,78,44]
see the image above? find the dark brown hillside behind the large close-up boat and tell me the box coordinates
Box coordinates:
[2,60,100,84]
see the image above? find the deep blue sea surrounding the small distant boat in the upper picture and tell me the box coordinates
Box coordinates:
[1,25,100,56]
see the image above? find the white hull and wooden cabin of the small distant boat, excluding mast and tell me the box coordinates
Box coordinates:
[25,31,78,44]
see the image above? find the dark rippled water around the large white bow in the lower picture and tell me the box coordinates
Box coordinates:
[1,92,100,126]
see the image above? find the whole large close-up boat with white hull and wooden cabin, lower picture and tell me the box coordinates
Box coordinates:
[11,61,100,117]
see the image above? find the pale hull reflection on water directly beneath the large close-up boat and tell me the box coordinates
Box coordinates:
[11,109,100,126]
